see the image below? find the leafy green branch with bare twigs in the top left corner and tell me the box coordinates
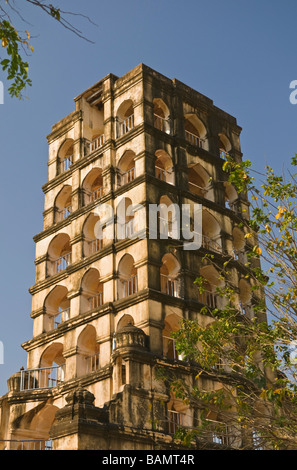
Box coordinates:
[0,0,91,99]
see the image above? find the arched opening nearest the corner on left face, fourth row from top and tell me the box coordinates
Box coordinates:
[117,254,137,299]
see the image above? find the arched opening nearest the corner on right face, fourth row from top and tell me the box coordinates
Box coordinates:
[160,253,180,297]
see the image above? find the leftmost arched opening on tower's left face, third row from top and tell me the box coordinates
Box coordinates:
[47,233,71,276]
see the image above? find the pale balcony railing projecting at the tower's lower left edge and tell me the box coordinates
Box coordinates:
[20,365,65,391]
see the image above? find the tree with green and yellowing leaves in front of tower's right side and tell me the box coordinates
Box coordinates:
[164,156,297,449]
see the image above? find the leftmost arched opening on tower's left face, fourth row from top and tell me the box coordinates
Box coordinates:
[44,286,70,331]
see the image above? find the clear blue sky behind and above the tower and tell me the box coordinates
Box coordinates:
[0,0,297,395]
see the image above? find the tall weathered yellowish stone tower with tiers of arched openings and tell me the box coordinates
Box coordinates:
[0,64,253,449]
